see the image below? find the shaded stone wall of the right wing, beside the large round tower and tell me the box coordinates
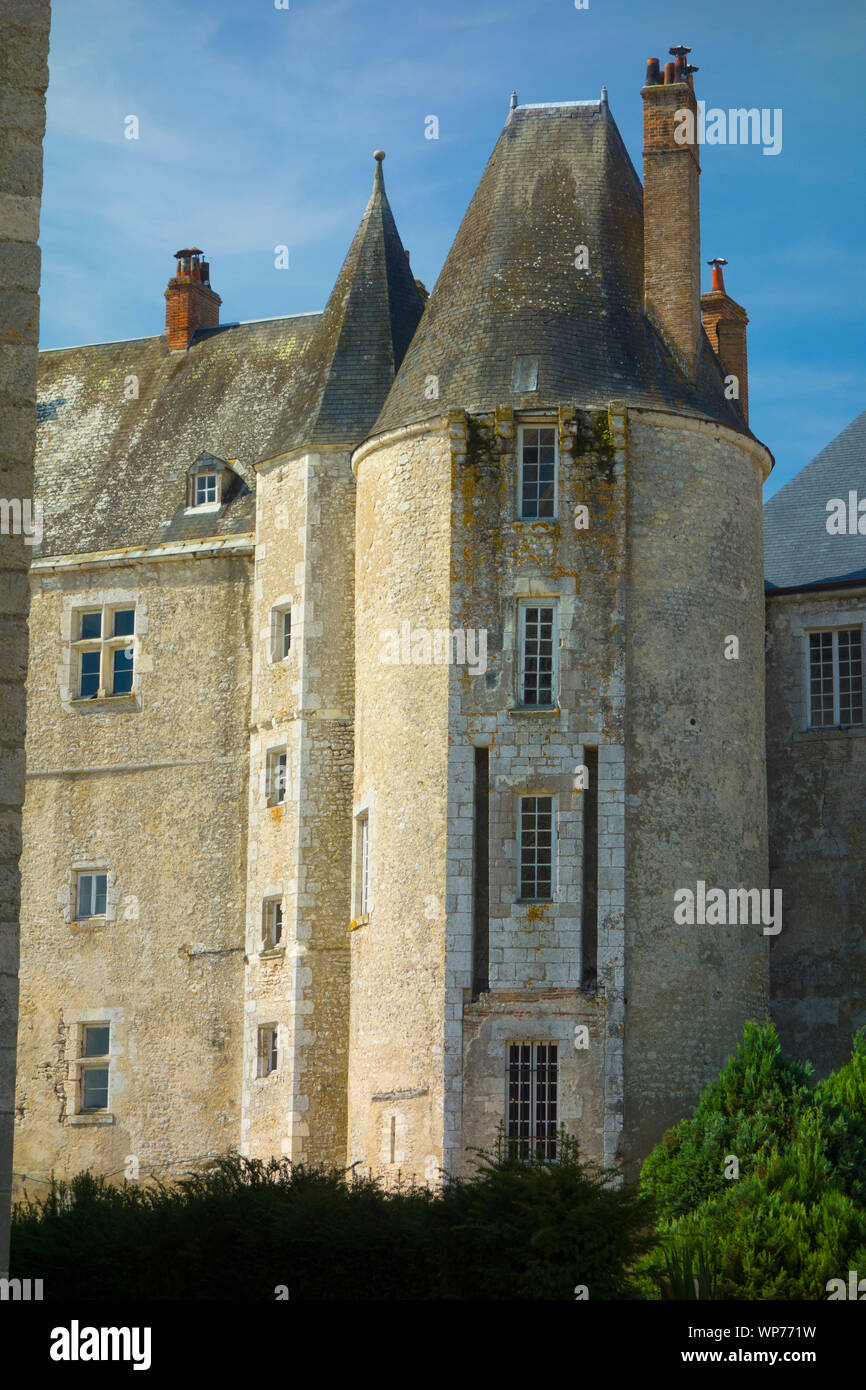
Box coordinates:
[767,589,866,1076]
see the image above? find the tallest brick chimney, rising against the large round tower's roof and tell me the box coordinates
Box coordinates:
[641,44,701,379]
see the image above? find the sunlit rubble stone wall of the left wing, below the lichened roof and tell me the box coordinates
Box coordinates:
[15,555,250,1193]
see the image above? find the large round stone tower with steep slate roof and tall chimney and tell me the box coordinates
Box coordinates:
[348,59,771,1179]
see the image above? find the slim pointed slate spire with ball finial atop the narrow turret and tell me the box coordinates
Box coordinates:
[264,152,424,457]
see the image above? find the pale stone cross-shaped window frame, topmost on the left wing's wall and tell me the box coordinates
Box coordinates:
[57,587,150,714]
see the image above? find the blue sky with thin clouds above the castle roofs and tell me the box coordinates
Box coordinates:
[40,0,866,496]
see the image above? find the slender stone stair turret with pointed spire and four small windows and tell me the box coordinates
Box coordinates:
[240,150,423,1162]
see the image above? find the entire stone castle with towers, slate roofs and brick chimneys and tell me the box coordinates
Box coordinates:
[8,49,866,1190]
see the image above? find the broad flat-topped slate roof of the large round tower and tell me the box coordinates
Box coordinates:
[374,99,749,434]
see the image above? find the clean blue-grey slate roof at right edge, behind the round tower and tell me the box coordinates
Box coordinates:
[763,410,866,592]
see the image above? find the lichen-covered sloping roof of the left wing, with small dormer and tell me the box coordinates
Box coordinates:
[35,314,320,555]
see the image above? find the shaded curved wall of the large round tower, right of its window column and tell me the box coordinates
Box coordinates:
[626,410,784,1158]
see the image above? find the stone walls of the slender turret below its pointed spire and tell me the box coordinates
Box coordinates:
[242,452,354,1163]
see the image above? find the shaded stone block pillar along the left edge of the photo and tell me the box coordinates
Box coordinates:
[0,0,50,1276]
